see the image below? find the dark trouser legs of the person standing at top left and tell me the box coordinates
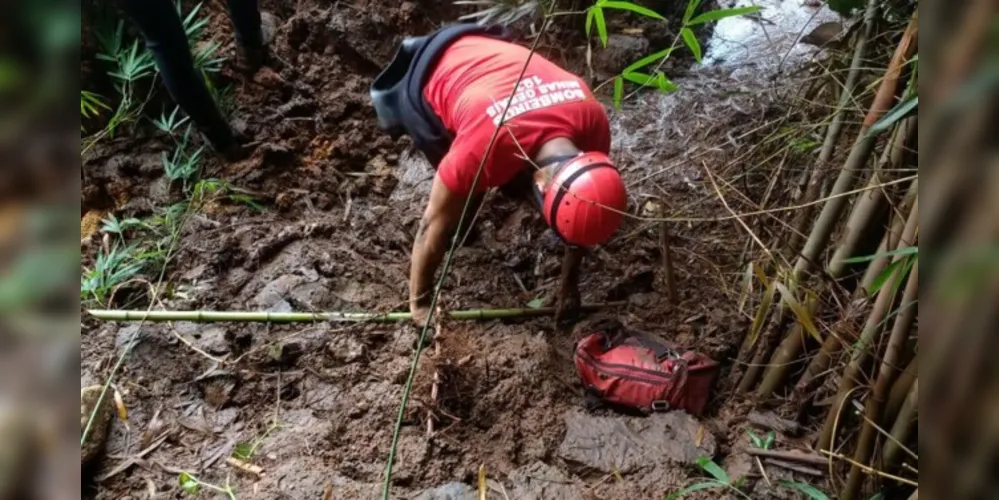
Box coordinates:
[120,0,263,152]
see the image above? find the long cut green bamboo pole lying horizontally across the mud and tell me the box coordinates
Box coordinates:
[87,301,627,323]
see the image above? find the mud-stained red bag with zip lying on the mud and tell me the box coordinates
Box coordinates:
[574,321,719,415]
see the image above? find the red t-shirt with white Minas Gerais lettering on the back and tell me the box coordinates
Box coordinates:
[423,36,610,194]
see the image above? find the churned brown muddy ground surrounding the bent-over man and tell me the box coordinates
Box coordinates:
[81,0,836,499]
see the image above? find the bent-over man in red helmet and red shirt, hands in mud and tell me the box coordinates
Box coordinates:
[372,25,627,324]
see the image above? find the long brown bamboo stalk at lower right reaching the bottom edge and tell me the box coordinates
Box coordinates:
[840,263,919,500]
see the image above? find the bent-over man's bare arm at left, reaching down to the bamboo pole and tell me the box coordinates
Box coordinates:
[409,176,467,321]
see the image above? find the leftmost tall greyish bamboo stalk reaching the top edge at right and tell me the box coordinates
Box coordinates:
[787,0,878,258]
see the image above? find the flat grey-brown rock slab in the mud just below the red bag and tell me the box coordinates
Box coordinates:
[558,410,716,473]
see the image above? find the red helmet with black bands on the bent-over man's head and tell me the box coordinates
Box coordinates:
[543,152,628,246]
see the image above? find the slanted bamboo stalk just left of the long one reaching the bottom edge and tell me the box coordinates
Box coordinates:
[817,199,919,449]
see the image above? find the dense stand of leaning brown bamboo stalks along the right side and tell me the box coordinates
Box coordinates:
[732,1,920,500]
